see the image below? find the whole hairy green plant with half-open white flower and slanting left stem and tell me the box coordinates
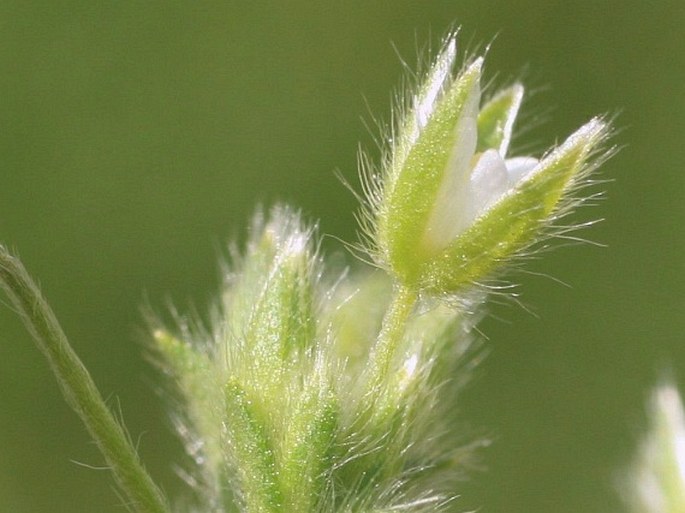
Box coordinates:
[0,36,609,513]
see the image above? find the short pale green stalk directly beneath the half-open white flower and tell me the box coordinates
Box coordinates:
[367,285,417,390]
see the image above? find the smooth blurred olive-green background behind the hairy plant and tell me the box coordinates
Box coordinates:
[0,0,685,513]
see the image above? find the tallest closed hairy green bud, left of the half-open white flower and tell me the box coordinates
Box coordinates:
[220,207,318,411]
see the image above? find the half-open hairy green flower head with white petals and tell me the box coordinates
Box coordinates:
[367,39,607,294]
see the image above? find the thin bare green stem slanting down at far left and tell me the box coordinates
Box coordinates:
[0,245,170,513]
